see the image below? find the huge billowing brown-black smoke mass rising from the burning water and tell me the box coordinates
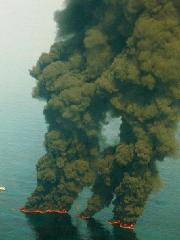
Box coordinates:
[26,0,180,223]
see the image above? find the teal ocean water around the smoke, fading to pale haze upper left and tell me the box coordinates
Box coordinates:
[0,0,180,240]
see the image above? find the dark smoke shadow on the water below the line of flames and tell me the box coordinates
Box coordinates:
[27,214,138,240]
